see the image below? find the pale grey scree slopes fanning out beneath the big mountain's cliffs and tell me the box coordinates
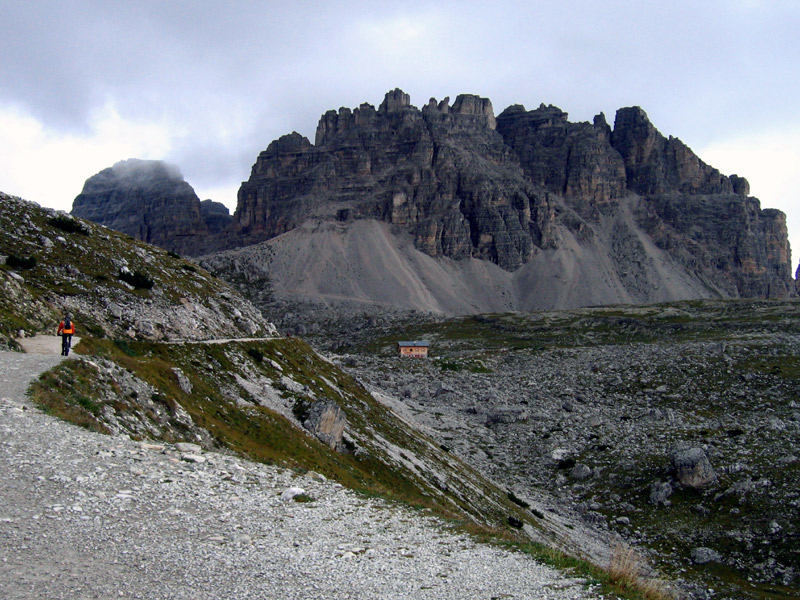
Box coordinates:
[199,210,717,324]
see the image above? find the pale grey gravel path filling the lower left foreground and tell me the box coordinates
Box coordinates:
[0,353,594,600]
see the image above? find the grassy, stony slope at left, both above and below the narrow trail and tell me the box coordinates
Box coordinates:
[0,196,646,596]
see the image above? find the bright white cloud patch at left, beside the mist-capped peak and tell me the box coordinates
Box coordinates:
[0,104,174,210]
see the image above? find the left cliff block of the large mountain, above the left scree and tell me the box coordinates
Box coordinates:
[234,90,553,269]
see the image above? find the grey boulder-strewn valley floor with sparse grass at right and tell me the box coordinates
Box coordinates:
[326,302,800,598]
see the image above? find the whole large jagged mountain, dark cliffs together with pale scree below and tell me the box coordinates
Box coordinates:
[75,89,797,314]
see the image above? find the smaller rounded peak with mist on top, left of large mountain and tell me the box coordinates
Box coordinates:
[72,159,232,255]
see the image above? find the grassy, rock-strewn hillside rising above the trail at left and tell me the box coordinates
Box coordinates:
[0,193,268,345]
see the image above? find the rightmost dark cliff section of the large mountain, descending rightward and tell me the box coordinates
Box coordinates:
[611,107,795,297]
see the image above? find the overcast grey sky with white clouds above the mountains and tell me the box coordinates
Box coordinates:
[0,0,800,272]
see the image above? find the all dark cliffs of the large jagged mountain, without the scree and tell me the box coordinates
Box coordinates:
[234,89,795,296]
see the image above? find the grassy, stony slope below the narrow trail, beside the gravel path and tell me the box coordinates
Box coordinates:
[29,338,518,526]
